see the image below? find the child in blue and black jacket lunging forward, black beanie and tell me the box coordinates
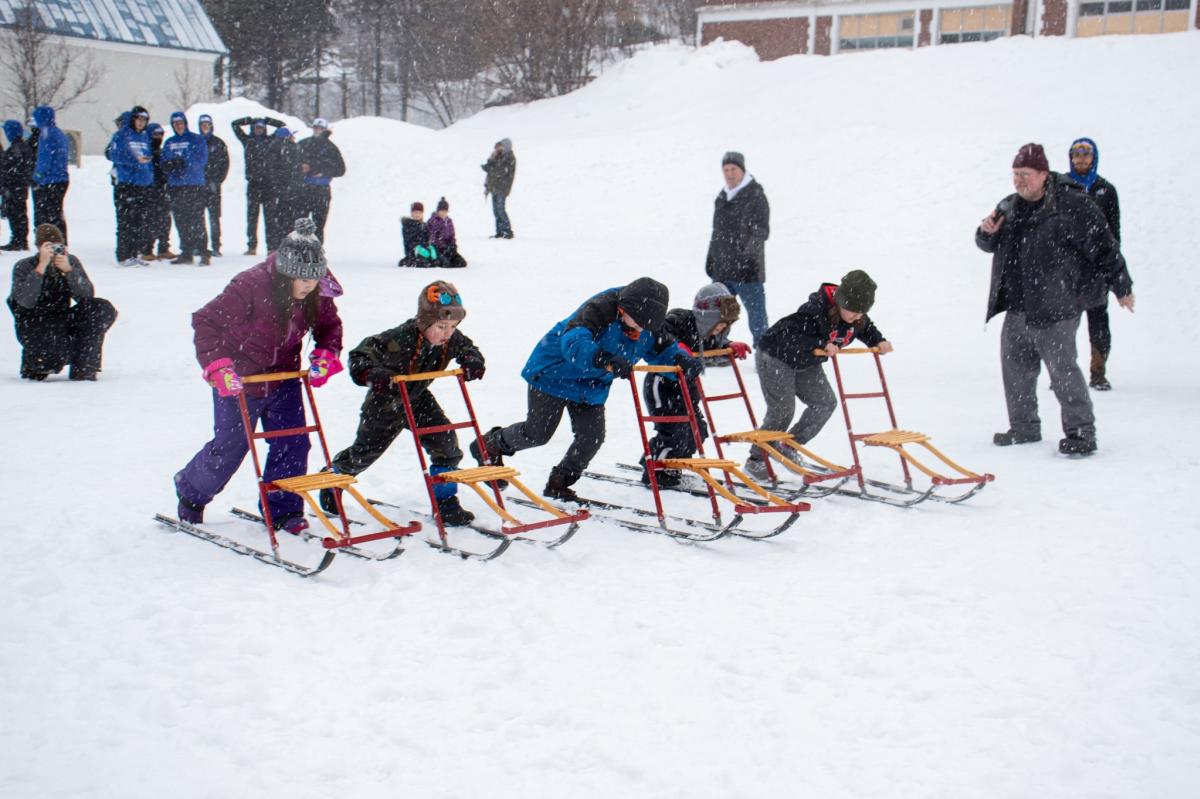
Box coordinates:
[470,277,701,501]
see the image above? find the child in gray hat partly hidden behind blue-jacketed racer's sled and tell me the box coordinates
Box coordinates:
[642,283,750,488]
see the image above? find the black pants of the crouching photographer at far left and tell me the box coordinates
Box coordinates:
[8,298,116,374]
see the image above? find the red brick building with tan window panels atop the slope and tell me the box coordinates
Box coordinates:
[697,0,1200,60]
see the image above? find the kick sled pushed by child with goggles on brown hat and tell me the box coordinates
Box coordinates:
[379,370,588,560]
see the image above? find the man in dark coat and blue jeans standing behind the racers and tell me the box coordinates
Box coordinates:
[704,151,770,347]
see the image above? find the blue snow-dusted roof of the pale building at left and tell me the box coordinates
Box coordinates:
[0,0,227,53]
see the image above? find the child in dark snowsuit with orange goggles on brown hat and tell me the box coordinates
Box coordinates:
[320,281,485,527]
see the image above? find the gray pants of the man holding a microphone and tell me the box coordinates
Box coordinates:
[1000,311,1096,438]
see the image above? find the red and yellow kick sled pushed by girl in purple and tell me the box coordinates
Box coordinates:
[155,371,421,577]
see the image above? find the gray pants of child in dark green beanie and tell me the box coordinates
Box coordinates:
[754,349,838,457]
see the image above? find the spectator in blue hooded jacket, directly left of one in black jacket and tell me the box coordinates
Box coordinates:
[161,112,212,266]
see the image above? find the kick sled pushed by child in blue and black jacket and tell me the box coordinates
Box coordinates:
[584,365,810,541]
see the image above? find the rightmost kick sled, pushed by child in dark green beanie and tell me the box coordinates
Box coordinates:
[814,347,996,507]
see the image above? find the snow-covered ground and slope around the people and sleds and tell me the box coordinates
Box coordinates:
[0,32,1200,799]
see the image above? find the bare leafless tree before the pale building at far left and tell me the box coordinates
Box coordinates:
[0,0,104,114]
